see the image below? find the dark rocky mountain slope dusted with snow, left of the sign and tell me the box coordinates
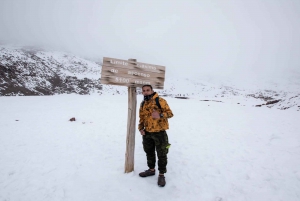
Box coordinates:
[0,46,101,96]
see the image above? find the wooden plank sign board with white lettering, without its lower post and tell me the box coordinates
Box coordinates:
[101,57,166,89]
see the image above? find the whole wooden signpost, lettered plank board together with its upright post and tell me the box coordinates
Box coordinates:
[101,57,166,173]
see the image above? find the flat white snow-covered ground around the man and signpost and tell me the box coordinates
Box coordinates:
[0,94,300,201]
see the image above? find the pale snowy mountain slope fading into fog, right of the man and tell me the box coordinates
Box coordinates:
[158,76,300,111]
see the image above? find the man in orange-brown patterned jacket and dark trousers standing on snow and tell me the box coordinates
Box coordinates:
[138,85,173,187]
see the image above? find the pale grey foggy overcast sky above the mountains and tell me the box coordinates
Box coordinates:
[0,0,300,80]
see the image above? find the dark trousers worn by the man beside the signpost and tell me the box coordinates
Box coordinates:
[143,131,170,174]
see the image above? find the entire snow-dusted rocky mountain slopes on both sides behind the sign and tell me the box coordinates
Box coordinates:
[0,45,300,111]
